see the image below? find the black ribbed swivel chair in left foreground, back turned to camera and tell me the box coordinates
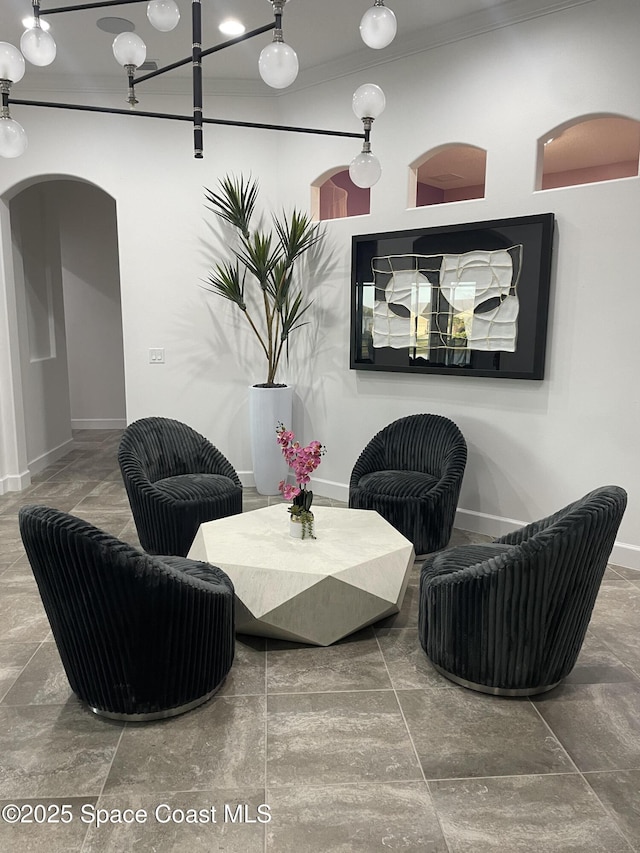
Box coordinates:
[19,506,235,721]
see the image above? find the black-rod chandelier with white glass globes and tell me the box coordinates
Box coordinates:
[0,0,397,187]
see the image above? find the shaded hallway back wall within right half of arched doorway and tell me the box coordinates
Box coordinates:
[57,181,126,429]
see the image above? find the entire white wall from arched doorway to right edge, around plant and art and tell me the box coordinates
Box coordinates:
[0,0,640,567]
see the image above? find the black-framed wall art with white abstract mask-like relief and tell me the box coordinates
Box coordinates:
[351,213,554,379]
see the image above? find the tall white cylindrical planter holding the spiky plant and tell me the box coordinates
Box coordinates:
[249,385,293,495]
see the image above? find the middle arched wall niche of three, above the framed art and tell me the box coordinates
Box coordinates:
[409,142,487,207]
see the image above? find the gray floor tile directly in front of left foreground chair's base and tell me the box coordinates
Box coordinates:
[104,696,265,794]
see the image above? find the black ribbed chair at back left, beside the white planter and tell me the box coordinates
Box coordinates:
[118,418,242,557]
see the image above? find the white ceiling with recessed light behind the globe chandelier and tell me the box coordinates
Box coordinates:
[6,0,593,97]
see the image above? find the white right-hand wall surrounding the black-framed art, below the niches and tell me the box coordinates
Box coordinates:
[276,0,640,567]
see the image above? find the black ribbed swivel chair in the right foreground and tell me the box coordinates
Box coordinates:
[419,486,627,696]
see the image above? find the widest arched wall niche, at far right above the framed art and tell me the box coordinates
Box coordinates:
[536,113,640,190]
